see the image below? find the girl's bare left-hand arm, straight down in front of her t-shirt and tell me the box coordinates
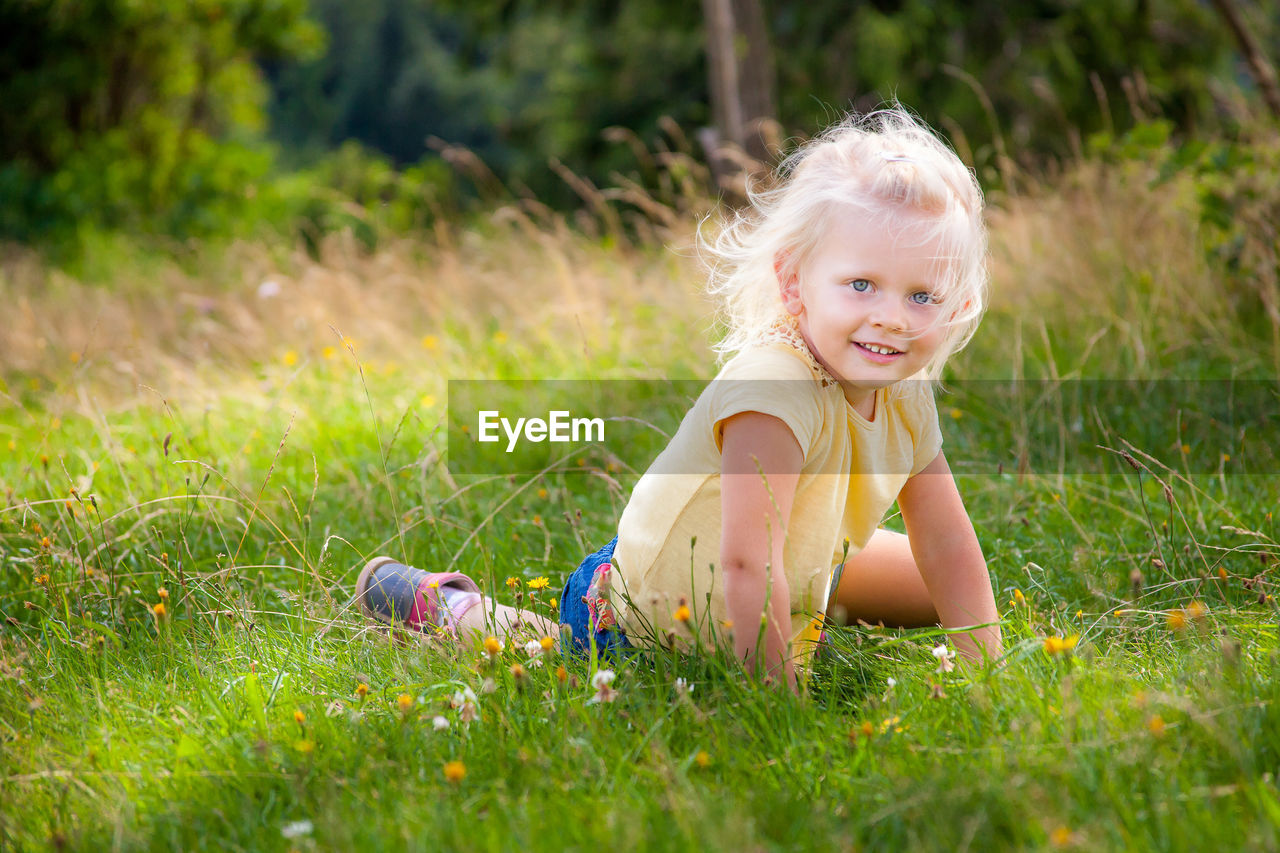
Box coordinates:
[721,411,804,690]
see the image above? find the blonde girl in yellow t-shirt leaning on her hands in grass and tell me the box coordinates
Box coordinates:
[357,106,1001,689]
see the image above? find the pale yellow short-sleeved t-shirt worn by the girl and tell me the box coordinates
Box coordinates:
[613,330,942,658]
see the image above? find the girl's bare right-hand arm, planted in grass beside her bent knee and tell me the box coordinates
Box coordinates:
[897,452,1001,660]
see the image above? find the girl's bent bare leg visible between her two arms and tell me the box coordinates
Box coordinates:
[832,529,938,628]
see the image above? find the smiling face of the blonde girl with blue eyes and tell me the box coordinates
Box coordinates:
[780,213,946,418]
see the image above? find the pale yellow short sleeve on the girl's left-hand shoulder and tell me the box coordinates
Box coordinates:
[709,348,823,459]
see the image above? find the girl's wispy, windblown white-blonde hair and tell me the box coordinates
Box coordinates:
[703,104,988,379]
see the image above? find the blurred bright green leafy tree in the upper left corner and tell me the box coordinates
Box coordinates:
[0,0,324,238]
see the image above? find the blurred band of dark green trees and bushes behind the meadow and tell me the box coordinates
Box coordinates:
[0,0,1280,256]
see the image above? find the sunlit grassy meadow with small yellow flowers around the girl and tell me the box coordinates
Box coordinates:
[0,154,1280,850]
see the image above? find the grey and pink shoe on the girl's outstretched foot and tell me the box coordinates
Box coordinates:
[356,557,480,633]
